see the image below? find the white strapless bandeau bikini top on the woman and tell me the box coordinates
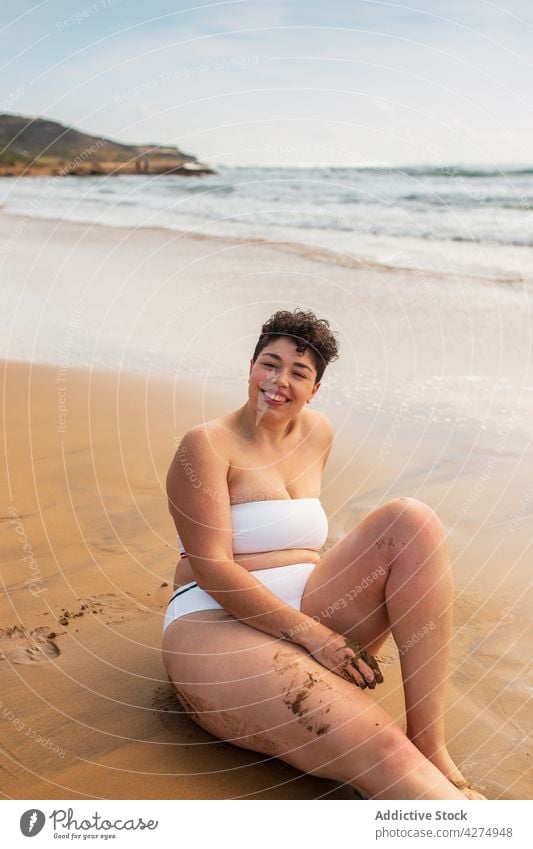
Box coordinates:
[178,498,328,557]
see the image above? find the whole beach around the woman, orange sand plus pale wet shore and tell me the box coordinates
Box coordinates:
[0,215,533,799]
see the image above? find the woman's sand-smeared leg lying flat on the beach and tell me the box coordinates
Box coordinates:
[163,611,464,799]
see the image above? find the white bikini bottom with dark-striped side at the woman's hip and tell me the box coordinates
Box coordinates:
[163,563,316,631]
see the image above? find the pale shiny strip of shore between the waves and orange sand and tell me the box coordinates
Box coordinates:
[0,214,533,435]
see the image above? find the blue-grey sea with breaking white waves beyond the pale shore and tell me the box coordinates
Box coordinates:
[0,166,533,282]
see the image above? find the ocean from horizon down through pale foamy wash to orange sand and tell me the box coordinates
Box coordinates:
[0,166,533,439]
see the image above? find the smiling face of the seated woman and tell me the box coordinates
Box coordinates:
[248,337,320,418]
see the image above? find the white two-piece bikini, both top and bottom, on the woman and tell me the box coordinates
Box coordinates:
[163,498,328,629]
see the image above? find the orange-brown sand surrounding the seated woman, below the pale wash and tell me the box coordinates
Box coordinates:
[0,362,533,799]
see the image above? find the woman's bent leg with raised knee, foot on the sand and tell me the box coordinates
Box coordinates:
[302,498,462,781]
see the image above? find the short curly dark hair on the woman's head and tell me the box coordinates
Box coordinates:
[252,309,339,383]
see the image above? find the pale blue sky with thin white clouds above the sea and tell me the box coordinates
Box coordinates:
[0,0,533,167]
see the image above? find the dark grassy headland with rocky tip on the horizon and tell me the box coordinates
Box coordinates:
[0,114,215,177]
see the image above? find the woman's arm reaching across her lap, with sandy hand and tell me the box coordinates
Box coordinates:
[167,426,375,686]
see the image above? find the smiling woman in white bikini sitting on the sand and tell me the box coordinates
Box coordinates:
[163,310,484,799]
